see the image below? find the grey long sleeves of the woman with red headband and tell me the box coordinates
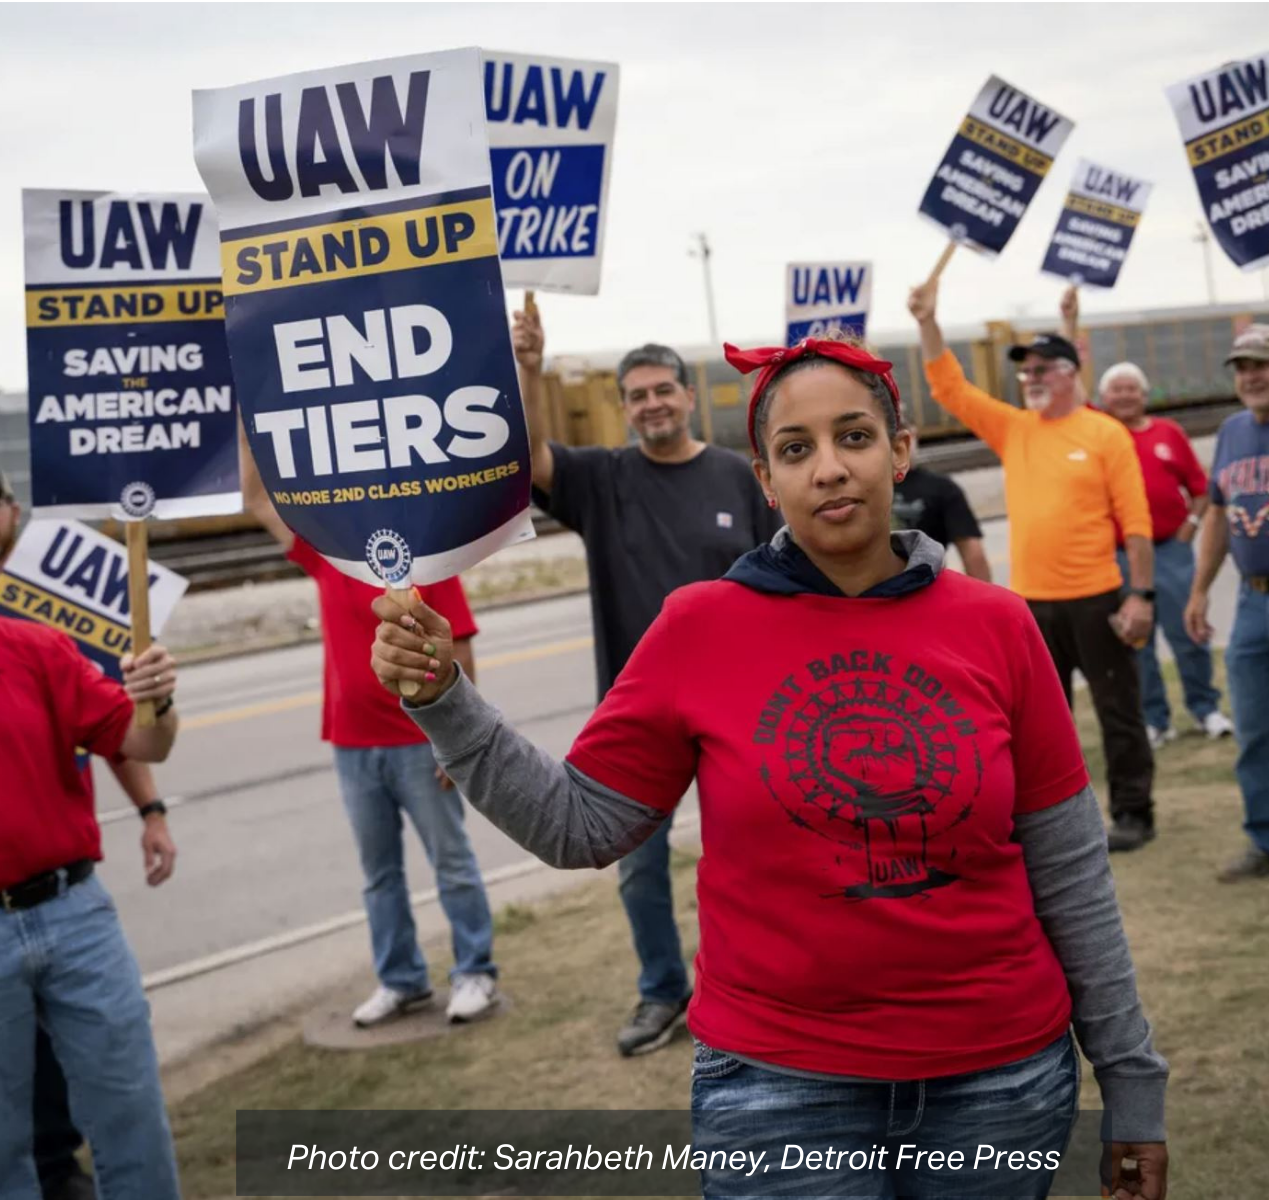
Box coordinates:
[402,672,1167,1142]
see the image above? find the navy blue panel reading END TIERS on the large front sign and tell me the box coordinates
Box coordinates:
[226,208,529,582]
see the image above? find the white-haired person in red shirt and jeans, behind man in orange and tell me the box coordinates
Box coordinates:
[1098,363,1233,750]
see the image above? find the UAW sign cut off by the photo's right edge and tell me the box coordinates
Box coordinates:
[1167,53,1269,270]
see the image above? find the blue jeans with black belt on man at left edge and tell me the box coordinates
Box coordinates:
[0,875,180,1200]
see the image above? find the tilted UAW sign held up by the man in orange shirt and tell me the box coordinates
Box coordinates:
[920,75,1075,255]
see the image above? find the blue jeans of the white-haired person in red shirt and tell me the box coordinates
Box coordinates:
[1119,538,1221,729]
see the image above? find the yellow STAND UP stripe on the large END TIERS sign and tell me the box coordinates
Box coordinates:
[221,197,497,296]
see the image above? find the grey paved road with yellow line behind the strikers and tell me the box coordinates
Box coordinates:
[98,521,1233,974]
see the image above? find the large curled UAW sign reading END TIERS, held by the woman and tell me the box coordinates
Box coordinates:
[194,49,533,587]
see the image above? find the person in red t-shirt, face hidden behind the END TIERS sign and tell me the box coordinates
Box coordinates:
[240,429,500,1027]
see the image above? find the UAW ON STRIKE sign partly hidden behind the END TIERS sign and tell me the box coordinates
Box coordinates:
[483,49,618,296]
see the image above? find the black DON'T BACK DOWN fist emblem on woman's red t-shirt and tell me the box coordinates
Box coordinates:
[754,649,983,901]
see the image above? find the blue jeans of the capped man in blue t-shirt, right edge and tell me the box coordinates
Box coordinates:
[1225,584,1269,854]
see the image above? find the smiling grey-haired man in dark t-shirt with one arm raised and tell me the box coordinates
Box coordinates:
[513,308,780,1055]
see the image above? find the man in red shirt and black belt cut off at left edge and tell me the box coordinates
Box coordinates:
[0,477,179,1200]
